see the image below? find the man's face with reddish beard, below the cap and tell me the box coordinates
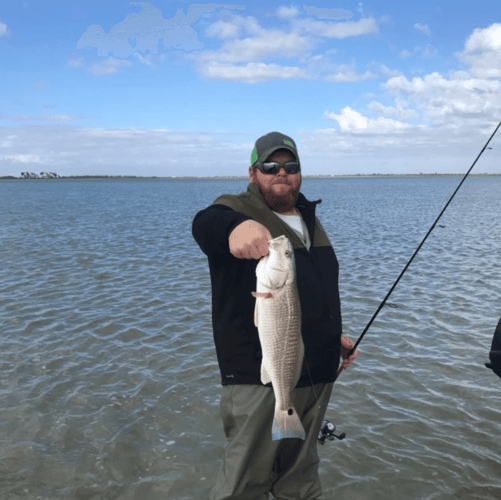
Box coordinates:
[249,149,301,214]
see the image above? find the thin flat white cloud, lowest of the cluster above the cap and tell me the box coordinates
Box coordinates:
[196,61,310,83]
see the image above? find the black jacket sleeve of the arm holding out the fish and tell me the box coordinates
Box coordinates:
[191,205,251,256]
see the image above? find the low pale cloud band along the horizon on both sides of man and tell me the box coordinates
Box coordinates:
[0,123,500,176]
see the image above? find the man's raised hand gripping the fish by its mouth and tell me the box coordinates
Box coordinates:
[228,220,271,259]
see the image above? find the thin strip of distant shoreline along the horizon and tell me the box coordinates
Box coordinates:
[0,173,501,181]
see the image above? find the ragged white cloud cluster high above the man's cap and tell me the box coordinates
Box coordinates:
[195,10,379,83]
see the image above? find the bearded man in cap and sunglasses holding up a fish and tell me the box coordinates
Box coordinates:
[193,132,356,500]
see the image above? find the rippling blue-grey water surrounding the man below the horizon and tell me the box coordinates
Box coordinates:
[0,177,501,500]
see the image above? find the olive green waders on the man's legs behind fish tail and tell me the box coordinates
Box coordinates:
[210,382,333,500]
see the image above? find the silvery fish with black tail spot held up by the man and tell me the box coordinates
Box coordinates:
[251,236,306,441]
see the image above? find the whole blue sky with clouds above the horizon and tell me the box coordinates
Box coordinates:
[0,0,501,177]
